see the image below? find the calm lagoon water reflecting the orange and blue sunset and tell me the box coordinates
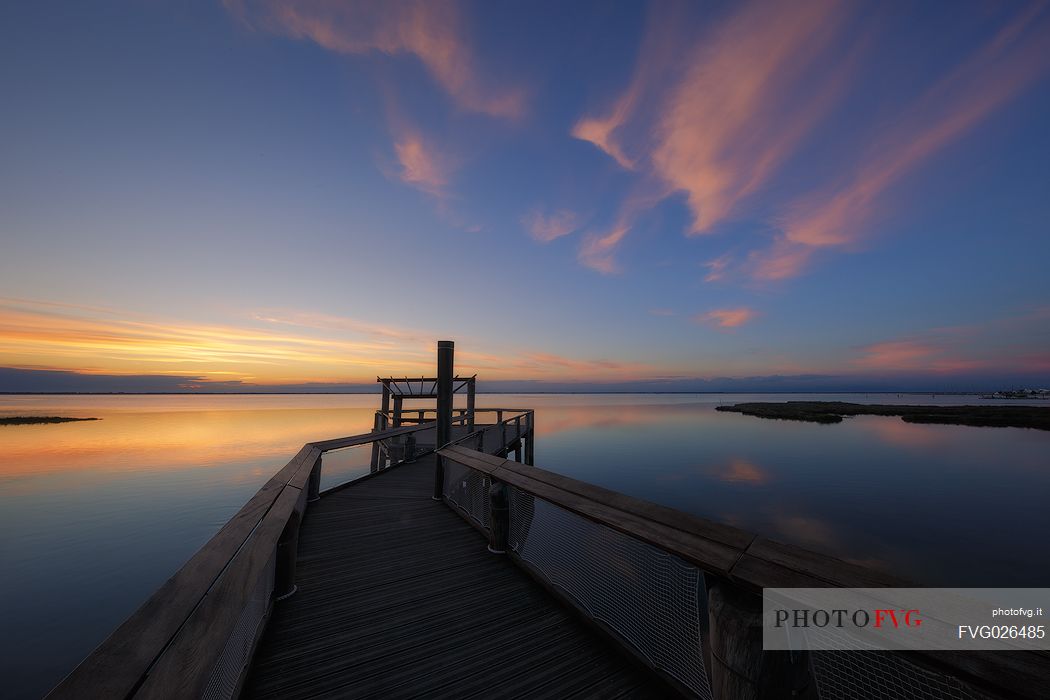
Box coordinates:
[0,395,1050,698]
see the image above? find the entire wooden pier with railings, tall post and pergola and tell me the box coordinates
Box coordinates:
[48,341,1050,700]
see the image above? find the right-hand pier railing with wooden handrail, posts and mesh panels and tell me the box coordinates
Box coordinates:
[438,444,1050,699]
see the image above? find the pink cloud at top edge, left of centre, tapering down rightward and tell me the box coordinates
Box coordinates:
[223,0,526,119]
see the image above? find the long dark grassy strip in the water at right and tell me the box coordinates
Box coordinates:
[717,401,1050,430]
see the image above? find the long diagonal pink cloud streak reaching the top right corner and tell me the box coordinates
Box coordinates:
[752,3,1050,279]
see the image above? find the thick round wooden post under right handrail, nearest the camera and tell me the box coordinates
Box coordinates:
[708,580,815,700]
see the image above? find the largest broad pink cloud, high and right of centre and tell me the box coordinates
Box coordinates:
[652,0,848,233]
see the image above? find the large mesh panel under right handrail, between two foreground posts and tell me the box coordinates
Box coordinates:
[508,488,711,700]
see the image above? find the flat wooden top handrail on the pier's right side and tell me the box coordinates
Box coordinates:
[438,446,1050,697]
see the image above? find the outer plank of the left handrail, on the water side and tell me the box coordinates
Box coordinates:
[47,478,294,700]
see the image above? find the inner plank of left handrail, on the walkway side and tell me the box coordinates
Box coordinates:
[135,486,301,699]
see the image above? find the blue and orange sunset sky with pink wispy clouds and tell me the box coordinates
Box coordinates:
[0,0,1050,391]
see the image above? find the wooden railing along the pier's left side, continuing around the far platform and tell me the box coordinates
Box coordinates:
[48,408,532,700]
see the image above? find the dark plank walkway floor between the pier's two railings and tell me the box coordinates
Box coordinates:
[244,455,666,698]
